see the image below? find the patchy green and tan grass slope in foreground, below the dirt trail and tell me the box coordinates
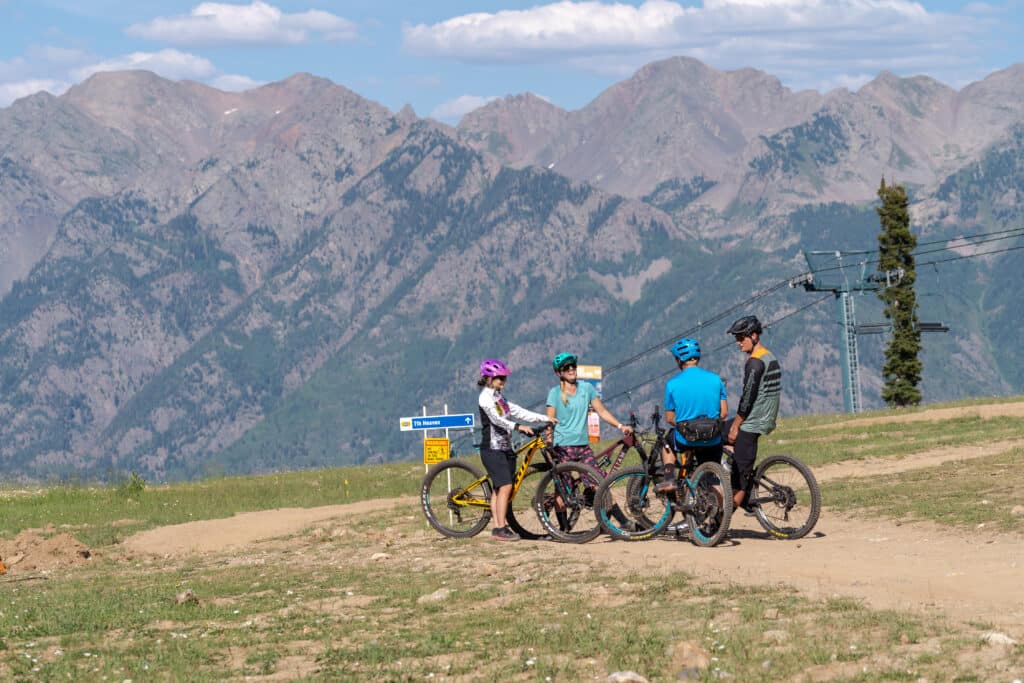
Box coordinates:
[0,504,1017,681]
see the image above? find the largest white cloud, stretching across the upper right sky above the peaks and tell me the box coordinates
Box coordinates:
[402,0,982,87]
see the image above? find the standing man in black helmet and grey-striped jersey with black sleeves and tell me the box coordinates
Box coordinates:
[722,315,782,509]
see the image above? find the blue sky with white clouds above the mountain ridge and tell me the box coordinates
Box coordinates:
[0,0,1024,123]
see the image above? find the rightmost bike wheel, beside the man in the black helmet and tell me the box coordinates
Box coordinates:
[750,455,821,541]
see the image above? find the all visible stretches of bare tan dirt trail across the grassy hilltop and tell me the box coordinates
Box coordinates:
[75,403,1024,641]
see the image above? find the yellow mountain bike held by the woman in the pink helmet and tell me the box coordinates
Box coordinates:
[420,423,603,543]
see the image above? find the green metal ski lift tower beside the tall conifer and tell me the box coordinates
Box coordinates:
[790,251,899,413]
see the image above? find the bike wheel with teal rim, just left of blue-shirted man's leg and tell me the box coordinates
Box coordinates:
[594,467,675,541]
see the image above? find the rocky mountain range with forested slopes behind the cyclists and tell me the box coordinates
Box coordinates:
[0,57,1024,478]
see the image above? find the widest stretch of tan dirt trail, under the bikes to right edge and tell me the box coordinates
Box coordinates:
[581,509,1024,639]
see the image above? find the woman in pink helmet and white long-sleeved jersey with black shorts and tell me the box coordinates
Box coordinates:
[476,358,557,541]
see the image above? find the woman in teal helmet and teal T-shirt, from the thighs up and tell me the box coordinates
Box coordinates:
[547,353,633,467]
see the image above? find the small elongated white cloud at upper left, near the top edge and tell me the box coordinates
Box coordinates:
[127,0,357,45]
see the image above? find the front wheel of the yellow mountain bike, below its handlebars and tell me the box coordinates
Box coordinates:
[534,463,603,543]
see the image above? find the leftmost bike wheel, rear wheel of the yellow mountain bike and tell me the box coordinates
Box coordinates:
[420,460,490,539]
